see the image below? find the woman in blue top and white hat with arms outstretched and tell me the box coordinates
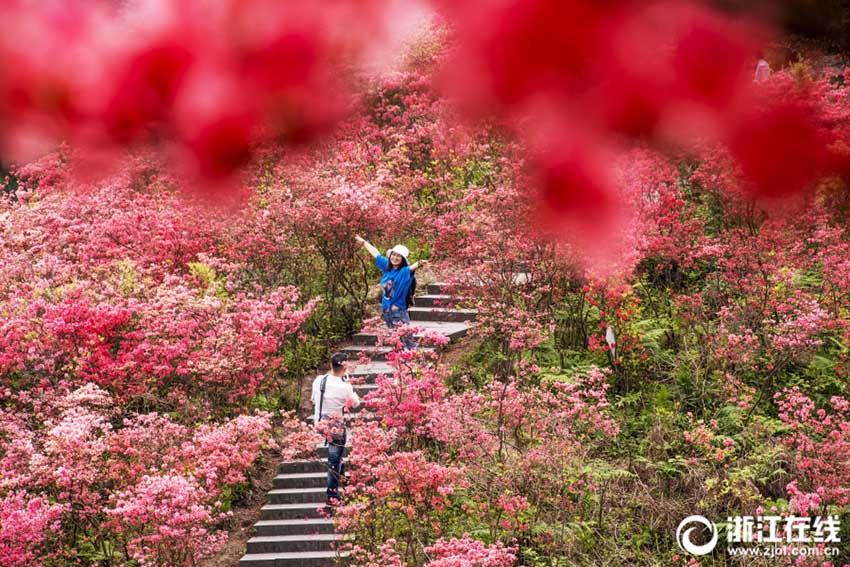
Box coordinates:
[356,236,428,350]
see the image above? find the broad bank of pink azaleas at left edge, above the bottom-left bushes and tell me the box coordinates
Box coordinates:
[0,158,317,408]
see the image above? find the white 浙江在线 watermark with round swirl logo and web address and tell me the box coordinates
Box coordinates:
[676,515,841,557]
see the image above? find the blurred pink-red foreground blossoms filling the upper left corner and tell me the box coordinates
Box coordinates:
[0,0,404,188]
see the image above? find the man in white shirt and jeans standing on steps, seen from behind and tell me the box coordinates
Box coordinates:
[311,352,360,506]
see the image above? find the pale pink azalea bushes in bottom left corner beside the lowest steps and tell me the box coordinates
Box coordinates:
[0,383,271,565]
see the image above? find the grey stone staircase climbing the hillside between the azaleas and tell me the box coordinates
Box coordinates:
[239,283,476,567]
